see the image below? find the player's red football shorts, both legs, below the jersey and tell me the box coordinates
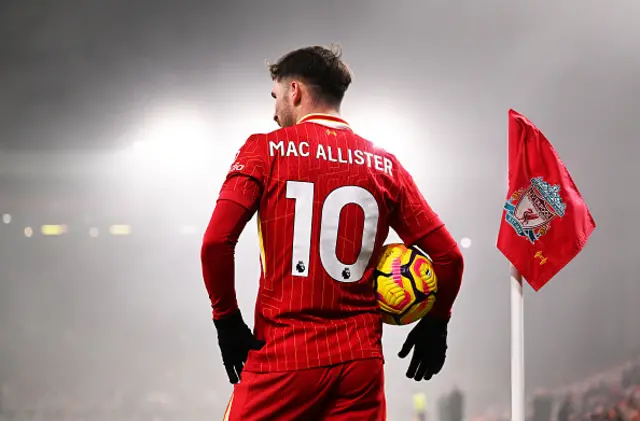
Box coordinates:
[224,358,386,421]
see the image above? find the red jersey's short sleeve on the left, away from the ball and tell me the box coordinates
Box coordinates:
[218,135,266,210]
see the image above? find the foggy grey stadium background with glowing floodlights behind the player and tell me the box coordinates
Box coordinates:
[0,0,640,420]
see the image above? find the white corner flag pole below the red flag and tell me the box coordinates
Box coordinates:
[511,265,525,421]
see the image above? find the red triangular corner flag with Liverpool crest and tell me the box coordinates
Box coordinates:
[498,110,596,291]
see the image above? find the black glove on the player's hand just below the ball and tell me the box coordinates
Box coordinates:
[398,316,448,381]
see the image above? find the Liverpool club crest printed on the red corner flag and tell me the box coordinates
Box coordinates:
[504,177,567,243]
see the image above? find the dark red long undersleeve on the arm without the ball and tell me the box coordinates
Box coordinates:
[200,200,253,319]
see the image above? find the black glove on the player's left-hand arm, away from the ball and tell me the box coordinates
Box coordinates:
[213,311,265,384]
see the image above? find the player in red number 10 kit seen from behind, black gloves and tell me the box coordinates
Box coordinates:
[201,46,463,421]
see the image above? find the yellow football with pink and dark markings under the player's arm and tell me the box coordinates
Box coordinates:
[374,243,438,325]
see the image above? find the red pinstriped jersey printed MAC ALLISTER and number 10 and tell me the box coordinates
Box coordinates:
[220,114,442,372]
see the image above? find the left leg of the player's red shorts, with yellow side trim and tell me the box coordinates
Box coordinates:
[224,367,339,421]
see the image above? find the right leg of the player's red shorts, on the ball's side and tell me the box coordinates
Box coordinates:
[322,358,387,421]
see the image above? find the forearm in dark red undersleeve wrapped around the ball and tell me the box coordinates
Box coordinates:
[415,226,464,319]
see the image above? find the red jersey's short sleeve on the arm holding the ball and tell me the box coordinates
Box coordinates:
[390,165,444,246]
